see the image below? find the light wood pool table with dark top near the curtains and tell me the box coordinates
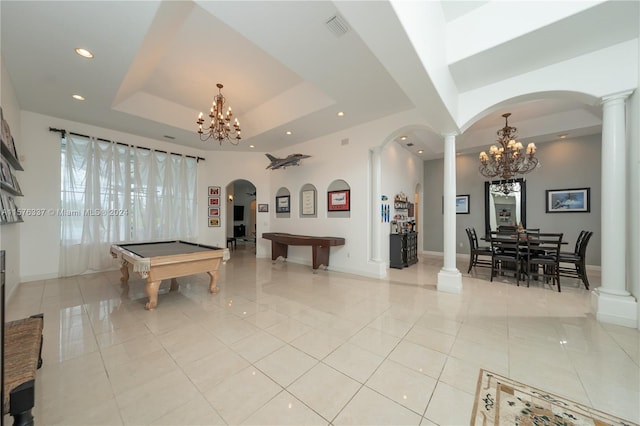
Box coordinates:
[110,241,224,309]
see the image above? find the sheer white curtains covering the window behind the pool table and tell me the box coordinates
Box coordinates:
[59,135,197,276]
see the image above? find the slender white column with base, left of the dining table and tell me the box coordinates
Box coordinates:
[438,134,462,293]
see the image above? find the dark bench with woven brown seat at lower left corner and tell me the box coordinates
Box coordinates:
[2,314,44,426]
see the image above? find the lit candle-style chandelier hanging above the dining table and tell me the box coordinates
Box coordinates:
[478,113,538,181]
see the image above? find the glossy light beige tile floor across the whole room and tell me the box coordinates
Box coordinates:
[5,244,640,426]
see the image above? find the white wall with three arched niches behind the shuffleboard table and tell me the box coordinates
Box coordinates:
[258,113,422,277]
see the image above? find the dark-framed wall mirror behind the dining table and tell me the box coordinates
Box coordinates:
[484,178,527,235]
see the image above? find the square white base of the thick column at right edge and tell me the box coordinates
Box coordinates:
[591,289,638,328]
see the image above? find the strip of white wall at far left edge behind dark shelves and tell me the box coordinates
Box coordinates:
[0,57,26,298]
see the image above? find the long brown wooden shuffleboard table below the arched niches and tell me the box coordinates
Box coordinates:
[262,232,344,272]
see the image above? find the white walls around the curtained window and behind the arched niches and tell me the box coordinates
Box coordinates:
[19,111,423,281]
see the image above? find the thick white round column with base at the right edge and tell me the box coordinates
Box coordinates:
[591,91,638,327]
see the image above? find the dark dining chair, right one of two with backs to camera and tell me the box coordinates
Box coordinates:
[523,232,563,292]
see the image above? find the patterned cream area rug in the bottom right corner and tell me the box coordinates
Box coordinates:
[471,370,638,426]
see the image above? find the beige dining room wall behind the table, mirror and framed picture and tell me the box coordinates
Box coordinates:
[424,134,602,266]
